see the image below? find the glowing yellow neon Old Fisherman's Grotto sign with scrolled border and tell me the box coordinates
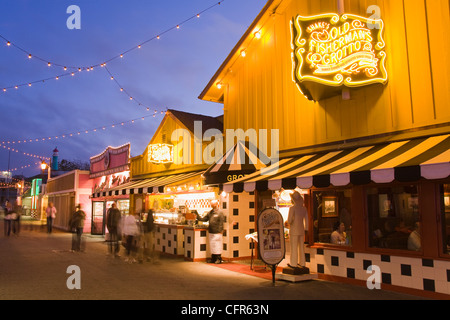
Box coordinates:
[292,14,388,101]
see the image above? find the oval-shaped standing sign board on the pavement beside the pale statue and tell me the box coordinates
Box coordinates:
[258,208,286,265]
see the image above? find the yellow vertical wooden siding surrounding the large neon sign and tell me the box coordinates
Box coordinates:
[211,0,450,154]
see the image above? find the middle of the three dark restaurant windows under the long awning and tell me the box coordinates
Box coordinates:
[367,185,422,251]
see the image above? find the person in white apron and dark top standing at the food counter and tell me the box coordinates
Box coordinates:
[197,200,226,264]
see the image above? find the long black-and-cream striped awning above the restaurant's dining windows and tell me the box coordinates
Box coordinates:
[224,135,450,192]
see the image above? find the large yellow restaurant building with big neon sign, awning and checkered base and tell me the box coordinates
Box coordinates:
[200,0,450,295]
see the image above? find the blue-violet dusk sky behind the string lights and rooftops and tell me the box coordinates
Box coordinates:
[0,0,266,176]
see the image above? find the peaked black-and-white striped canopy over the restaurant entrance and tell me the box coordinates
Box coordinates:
[203,141,270,185]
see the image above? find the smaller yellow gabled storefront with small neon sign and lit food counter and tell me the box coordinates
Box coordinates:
[113,110,226,261]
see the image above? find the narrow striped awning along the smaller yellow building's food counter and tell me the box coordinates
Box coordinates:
[93,171,203,198]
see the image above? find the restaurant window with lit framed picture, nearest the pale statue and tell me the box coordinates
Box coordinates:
[312,189,352,246]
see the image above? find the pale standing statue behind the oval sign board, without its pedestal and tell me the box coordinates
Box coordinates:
[287,191,309,272]
